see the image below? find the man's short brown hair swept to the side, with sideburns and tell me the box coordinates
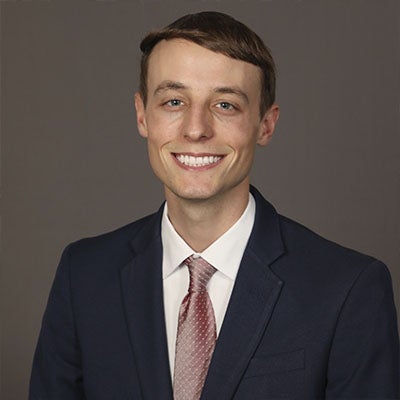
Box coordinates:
[139,11,276,115]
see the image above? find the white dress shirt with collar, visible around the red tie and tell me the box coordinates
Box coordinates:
[161,194,256,377]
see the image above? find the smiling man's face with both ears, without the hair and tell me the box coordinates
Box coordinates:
[135,39,279,200]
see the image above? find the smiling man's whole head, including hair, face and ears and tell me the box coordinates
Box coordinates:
[135,12,279,204]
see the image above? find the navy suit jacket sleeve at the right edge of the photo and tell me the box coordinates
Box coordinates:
[326,261,400,400]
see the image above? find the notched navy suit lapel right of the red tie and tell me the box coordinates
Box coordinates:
[202,188,284,400]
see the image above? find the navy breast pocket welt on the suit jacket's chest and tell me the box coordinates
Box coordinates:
[244,349,305,378]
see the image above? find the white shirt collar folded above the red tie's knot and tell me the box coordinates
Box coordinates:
[161,193,256,280]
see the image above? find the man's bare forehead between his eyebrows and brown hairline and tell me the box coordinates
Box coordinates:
[147,39,261,97]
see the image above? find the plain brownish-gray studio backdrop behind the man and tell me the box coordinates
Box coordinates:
[0,0,400,400]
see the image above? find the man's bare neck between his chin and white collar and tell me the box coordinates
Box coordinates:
[166,182,249,253]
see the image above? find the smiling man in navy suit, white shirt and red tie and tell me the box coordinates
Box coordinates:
[30,12,399,400]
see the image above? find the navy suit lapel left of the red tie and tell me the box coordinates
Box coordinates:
[121,206,172,400]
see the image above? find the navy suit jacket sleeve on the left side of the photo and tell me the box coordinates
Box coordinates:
[29,247,85,400]
